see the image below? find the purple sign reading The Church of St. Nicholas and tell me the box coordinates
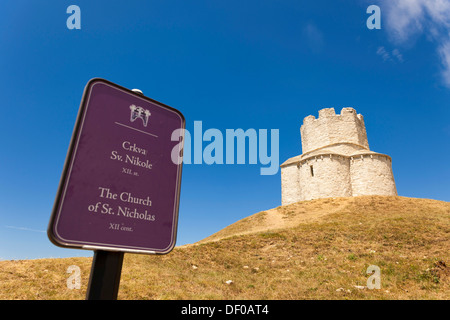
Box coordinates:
[48,79,185,254]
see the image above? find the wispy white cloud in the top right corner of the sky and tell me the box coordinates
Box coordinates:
[382,0,450,88]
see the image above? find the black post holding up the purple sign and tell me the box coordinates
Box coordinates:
[86,250,124,300]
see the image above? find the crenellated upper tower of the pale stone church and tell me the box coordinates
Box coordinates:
[300,107,369,153]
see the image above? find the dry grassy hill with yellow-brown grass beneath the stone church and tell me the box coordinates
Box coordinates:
[0,196,450,300]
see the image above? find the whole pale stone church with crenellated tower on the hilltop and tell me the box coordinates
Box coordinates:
[281,108,397,205]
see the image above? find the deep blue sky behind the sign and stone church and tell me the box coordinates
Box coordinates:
[0,0,450,259]
